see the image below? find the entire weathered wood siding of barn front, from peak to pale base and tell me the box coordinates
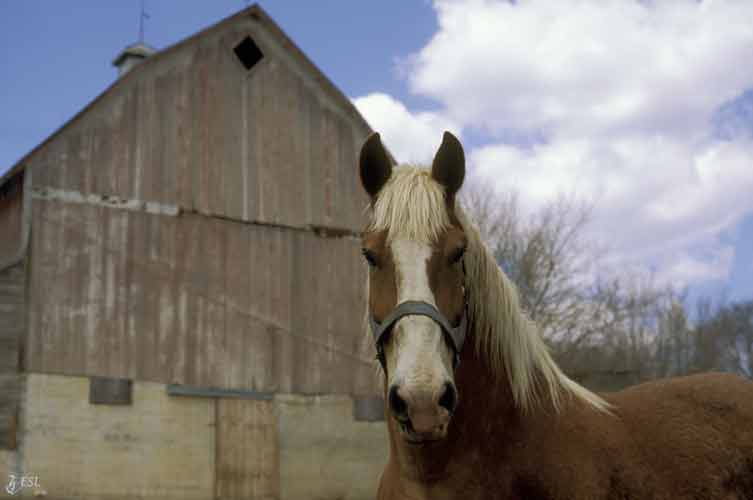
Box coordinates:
[13,9,375,394]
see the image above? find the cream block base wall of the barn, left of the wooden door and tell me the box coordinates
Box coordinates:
[2,374,215,500]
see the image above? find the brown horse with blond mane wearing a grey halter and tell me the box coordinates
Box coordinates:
[359,133,753,500]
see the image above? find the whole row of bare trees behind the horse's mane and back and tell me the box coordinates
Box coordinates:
[462,184,753,383]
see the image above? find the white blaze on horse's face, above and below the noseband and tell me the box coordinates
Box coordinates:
[385,239,452,390]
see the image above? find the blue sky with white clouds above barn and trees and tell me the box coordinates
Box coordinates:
[0,0,753,300]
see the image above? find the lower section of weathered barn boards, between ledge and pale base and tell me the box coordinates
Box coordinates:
[26,198,378,394]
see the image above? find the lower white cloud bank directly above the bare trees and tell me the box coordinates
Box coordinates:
[469,133,753,268]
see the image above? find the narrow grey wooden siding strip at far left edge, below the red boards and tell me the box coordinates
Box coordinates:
[0,263,26,449]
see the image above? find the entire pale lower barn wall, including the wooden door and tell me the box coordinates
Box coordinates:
[0,374,388,500]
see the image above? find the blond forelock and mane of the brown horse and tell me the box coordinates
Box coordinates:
[369,166,609,412]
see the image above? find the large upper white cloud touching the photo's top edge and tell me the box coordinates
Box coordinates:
[402,0,753,141]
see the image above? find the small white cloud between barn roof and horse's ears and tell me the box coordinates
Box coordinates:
[353,93,460,163]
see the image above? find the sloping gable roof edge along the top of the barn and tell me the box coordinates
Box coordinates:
[0,4,371,187]
